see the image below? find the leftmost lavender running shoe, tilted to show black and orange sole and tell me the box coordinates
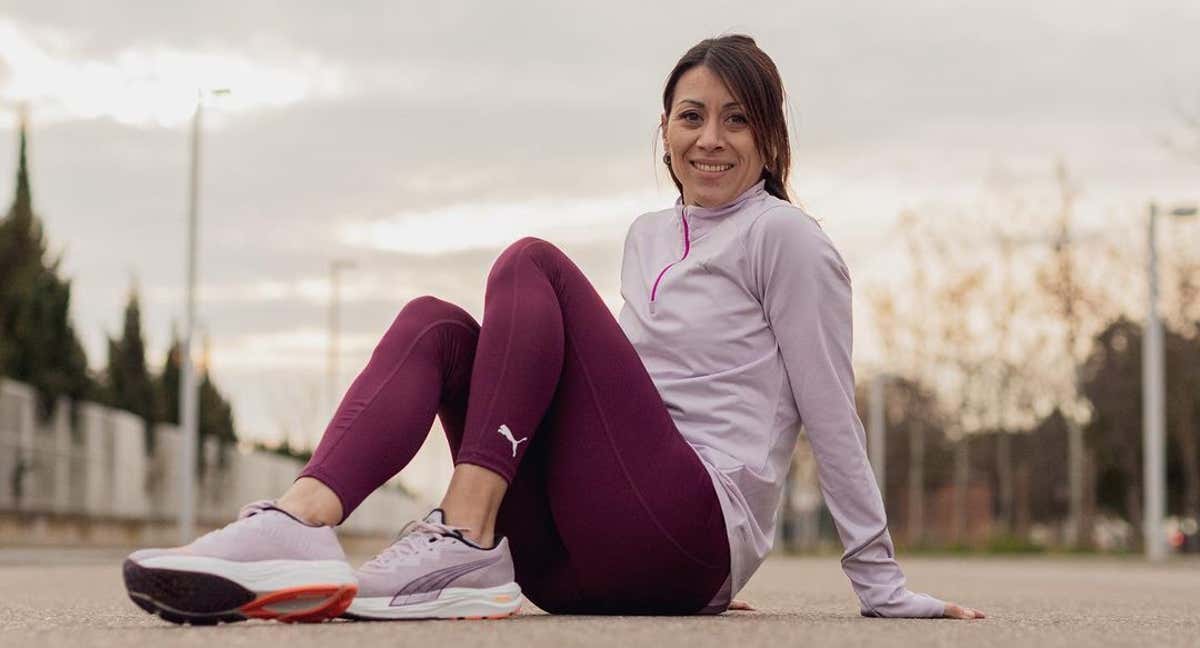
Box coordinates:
[125,500,358,625]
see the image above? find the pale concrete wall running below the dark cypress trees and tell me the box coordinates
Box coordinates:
[0,378,424,535]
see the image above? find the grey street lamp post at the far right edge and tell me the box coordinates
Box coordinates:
[1141,203,1196,562]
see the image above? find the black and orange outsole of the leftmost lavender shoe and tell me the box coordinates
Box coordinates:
[122,560,359,625]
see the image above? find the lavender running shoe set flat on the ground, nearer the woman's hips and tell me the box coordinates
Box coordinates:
[343,509,521,619]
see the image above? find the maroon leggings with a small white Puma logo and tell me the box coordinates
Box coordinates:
[301,238,730,614]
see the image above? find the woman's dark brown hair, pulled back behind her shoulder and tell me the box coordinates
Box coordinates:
[662,34,792,202]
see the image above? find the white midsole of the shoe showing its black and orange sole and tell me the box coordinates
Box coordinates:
[138,556,358,593]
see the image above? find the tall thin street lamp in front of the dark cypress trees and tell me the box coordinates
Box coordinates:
[179,88,229,544]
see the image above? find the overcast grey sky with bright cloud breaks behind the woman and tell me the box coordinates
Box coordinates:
[0,0,1200,468]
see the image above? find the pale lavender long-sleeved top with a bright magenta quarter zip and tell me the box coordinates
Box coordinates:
[619,182,944,617]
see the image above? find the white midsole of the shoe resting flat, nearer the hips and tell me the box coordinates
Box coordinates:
[347,583,521,619]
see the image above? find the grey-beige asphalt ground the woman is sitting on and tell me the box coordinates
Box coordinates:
[0,550,1200,648]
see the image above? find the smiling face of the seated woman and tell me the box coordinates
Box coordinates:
[662,65,763,208]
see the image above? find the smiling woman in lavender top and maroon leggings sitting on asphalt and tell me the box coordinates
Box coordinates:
[125,36,983,623]
